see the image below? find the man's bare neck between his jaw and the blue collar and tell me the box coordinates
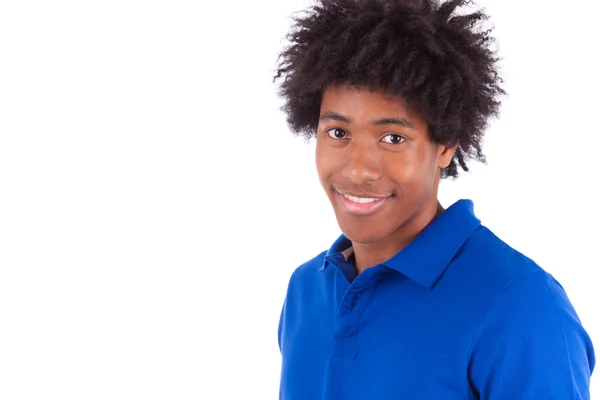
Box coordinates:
[352,200,444,274]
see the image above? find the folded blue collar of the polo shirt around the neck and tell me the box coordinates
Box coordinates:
[320,200,481,287]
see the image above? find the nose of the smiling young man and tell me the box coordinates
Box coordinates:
[342,142,381,185]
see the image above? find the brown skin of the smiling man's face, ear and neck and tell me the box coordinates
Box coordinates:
[316,85,456,273]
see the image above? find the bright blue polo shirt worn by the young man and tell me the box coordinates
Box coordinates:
[279,200,595,400]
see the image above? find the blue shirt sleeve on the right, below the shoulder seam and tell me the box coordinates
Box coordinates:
[469,271,595,400]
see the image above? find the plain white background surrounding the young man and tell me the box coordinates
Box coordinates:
[0,0,600,400]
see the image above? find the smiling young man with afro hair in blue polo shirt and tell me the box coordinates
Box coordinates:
[276,0,595,400]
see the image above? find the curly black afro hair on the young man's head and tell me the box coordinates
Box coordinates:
[273,0,505,178]
